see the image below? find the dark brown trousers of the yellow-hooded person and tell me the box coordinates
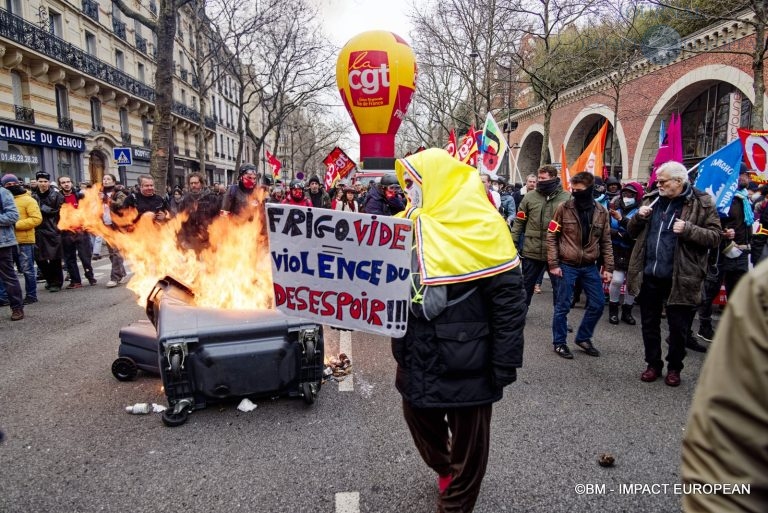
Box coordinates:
[403,400,493,513]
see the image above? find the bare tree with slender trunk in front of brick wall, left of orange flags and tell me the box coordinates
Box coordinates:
[508,0,597,165]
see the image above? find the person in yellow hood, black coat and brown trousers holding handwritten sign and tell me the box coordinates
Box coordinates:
[392,148,527,513]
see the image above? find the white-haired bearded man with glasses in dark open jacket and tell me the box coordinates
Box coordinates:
[627,162,721,387]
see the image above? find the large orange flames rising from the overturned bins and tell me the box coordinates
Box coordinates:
[58,187,274,309]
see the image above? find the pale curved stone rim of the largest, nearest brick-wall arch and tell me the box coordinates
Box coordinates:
[631,64,755,179]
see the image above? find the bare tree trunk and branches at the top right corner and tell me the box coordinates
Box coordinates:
[650,0,768,130]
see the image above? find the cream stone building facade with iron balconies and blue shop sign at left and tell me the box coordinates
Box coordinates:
[0,0,254,189]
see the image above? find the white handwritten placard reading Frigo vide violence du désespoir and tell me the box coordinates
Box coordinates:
[267,204,413,337]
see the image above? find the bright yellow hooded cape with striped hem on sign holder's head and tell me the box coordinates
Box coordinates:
[395,148,520,285]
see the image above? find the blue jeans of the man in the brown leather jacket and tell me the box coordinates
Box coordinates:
[552,263,605,345]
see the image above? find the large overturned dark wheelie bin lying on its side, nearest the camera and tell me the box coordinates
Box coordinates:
[147,278,324,426]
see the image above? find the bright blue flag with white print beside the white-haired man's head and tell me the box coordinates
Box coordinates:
[693,139,743,217]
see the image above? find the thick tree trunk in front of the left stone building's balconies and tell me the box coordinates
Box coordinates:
[149,0,177,194]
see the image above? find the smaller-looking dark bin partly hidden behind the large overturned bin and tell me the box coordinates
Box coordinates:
[112,320,160,381]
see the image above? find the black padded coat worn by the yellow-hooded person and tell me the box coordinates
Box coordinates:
[392,266,527,408]
